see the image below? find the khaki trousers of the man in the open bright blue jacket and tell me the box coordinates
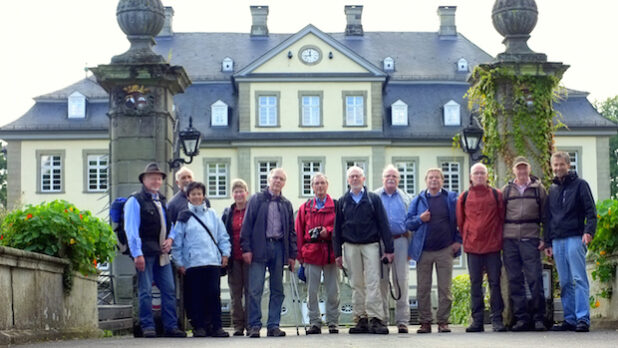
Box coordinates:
[416,245,453,323]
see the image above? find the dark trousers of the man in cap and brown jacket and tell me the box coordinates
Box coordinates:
[503,238,545,322]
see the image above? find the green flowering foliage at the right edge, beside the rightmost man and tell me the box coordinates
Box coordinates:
[588,199,618,304]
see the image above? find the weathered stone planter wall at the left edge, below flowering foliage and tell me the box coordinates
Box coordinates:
[0,246,102,347]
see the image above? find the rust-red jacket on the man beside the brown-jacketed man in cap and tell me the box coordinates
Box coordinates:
[457,185,504,254]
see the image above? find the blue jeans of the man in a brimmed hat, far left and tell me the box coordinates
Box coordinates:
[137,256,178,331]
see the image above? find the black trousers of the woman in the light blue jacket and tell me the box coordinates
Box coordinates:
[185,266,221,332]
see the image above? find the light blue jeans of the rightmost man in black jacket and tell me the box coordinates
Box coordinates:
[552,236,590,325]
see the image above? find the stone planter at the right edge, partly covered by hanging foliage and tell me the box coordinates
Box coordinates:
[586,255,618,329]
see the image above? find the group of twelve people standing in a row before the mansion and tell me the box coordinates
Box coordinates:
[124,152,596,337]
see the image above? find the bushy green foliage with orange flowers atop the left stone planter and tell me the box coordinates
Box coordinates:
[0,200,116,292]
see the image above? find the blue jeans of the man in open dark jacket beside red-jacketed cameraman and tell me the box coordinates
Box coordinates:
[248,241,284,329]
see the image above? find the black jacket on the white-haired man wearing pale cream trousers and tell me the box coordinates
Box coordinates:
[333,188,394,257]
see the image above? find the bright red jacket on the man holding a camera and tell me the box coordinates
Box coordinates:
[296,195,335,266]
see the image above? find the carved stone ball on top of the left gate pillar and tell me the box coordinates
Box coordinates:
[116,0,165,37]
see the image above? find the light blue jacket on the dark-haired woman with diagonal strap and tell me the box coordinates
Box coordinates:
[172,203,231,269]
